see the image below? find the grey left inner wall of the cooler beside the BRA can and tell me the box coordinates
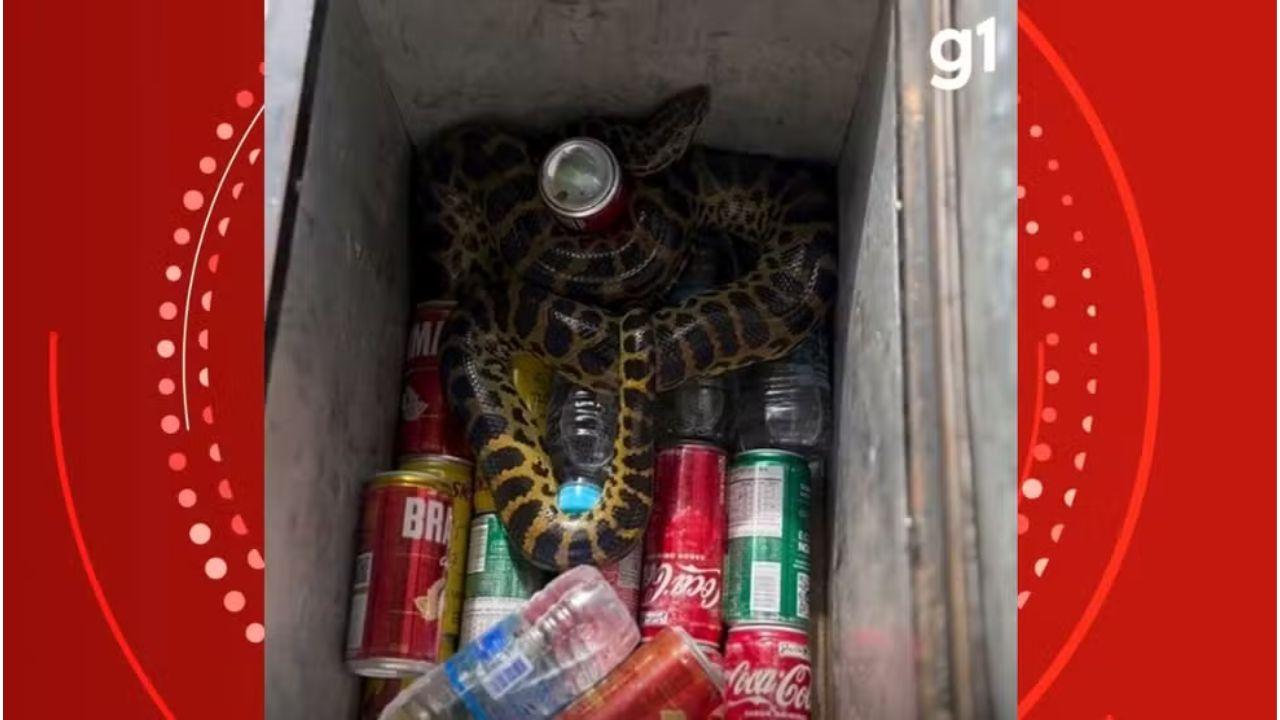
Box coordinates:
[265,0,411,720]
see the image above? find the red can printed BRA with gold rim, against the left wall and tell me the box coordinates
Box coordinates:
[347,470,453,678]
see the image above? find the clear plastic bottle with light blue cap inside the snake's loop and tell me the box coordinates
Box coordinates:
[545,375,618,512]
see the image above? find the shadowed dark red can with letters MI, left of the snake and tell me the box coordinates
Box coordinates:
[399,300,471,460]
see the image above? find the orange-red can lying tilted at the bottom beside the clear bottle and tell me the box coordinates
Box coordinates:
[557,628,724,720]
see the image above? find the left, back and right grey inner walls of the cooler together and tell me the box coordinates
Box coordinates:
[266,0,916,719]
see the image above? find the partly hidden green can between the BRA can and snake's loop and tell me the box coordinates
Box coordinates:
[460,474,547,646]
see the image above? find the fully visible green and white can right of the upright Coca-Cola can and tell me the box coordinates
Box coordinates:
[724,450,810,628]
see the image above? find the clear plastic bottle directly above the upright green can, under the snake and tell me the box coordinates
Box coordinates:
[736,325,832,457]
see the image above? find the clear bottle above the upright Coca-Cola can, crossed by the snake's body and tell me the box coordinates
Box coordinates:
[658,237,733,448]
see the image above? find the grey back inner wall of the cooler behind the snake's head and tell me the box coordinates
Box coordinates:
[357,0,881,163]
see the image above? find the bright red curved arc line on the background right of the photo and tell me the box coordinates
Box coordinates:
[1018,10,1160,717]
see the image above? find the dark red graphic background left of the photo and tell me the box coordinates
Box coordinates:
[4,0,262,719]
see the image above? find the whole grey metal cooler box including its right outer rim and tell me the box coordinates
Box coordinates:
[265,0,1016,720]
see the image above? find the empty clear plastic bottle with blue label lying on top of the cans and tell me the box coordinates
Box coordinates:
[381,565,640,720]
